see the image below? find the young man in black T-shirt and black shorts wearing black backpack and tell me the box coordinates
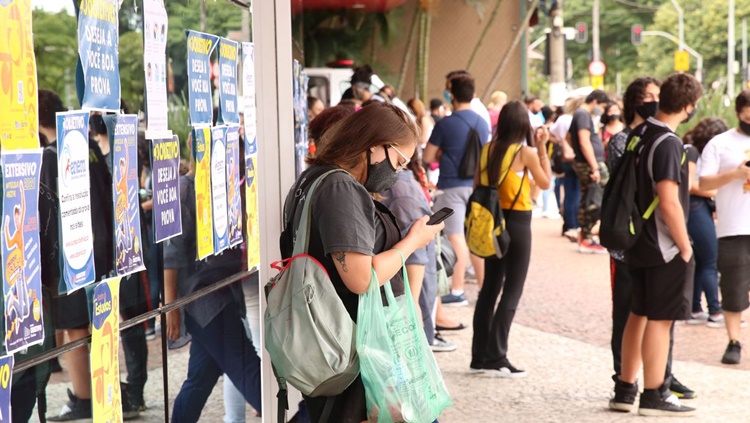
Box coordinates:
[602,74,703,416]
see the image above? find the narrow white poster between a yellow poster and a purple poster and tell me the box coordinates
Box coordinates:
[211,126,229,254]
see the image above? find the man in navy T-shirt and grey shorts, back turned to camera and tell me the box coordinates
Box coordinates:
[423,74,490,306]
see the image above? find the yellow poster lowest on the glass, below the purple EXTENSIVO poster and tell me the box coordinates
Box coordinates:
[91,277,122,423]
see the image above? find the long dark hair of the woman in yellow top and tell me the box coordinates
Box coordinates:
[487,101,533,184]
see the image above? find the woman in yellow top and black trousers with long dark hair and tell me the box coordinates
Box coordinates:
[470,101,551,377]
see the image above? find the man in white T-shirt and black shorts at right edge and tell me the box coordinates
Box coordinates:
[700,90,750,364]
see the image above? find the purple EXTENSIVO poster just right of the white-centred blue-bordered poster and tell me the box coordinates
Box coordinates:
[110,115,146,276]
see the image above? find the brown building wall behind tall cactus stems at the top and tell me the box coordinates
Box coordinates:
[375,0,524,101]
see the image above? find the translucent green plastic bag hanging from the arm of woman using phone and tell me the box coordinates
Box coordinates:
[357,267,453,423]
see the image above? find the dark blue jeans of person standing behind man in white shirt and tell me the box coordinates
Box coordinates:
[688,199,721,314]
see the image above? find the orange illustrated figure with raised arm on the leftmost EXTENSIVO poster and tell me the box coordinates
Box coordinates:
[4,182,33,338]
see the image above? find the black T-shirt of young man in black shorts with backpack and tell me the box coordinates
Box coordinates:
[626,118,690,267]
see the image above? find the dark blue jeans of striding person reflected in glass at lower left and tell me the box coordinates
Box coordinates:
[172,307,262,423]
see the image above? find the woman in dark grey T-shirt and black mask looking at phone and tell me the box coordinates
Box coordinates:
[280,102,444,423]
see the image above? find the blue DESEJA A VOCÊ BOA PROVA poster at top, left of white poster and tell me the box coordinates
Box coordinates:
[78,0,120,111]
